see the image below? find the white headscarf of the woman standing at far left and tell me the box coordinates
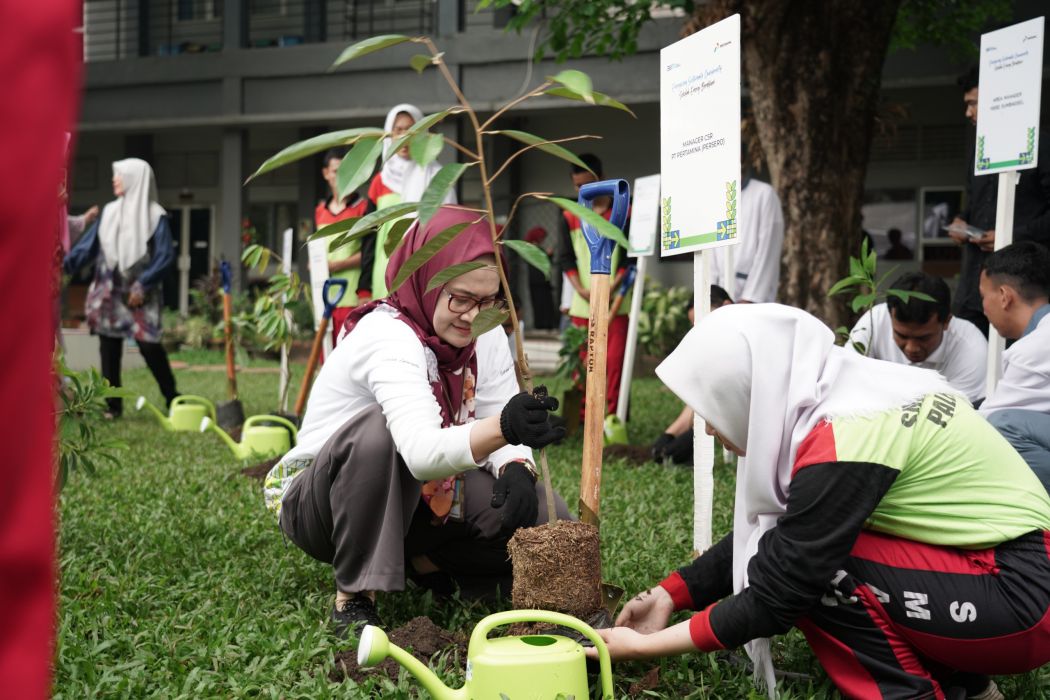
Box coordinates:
[99,158,166,272]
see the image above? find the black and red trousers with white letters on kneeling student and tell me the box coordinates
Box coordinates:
[797,531,1050,700]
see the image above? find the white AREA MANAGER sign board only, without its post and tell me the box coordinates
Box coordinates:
[973,17,1044,175]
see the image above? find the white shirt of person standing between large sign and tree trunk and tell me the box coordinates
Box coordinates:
[712,178,784,303]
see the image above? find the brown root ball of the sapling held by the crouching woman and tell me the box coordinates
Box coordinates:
[507,521,602,619]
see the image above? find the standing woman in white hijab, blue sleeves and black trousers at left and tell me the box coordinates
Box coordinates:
[63,158,179,418]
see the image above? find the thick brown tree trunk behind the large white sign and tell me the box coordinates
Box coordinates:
[687,0,901,327]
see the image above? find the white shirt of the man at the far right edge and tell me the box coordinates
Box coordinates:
[981,314,1050,416]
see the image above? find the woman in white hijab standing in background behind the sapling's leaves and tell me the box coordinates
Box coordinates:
[361,104,456,299]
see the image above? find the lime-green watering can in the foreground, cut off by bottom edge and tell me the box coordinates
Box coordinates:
[357,610,612,700]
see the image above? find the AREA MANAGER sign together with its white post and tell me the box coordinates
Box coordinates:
[967,17,1044,395]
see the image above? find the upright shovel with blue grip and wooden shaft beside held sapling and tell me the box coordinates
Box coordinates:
[579,179,630,527]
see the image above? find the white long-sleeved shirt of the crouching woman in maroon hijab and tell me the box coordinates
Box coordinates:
[285,304,532,482]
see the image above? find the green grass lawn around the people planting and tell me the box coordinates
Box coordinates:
[55,353,1050,699]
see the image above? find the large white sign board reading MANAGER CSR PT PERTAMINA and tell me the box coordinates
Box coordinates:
[659,15,740,255]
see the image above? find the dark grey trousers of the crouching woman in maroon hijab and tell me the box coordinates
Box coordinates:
[280,406,570,593]
